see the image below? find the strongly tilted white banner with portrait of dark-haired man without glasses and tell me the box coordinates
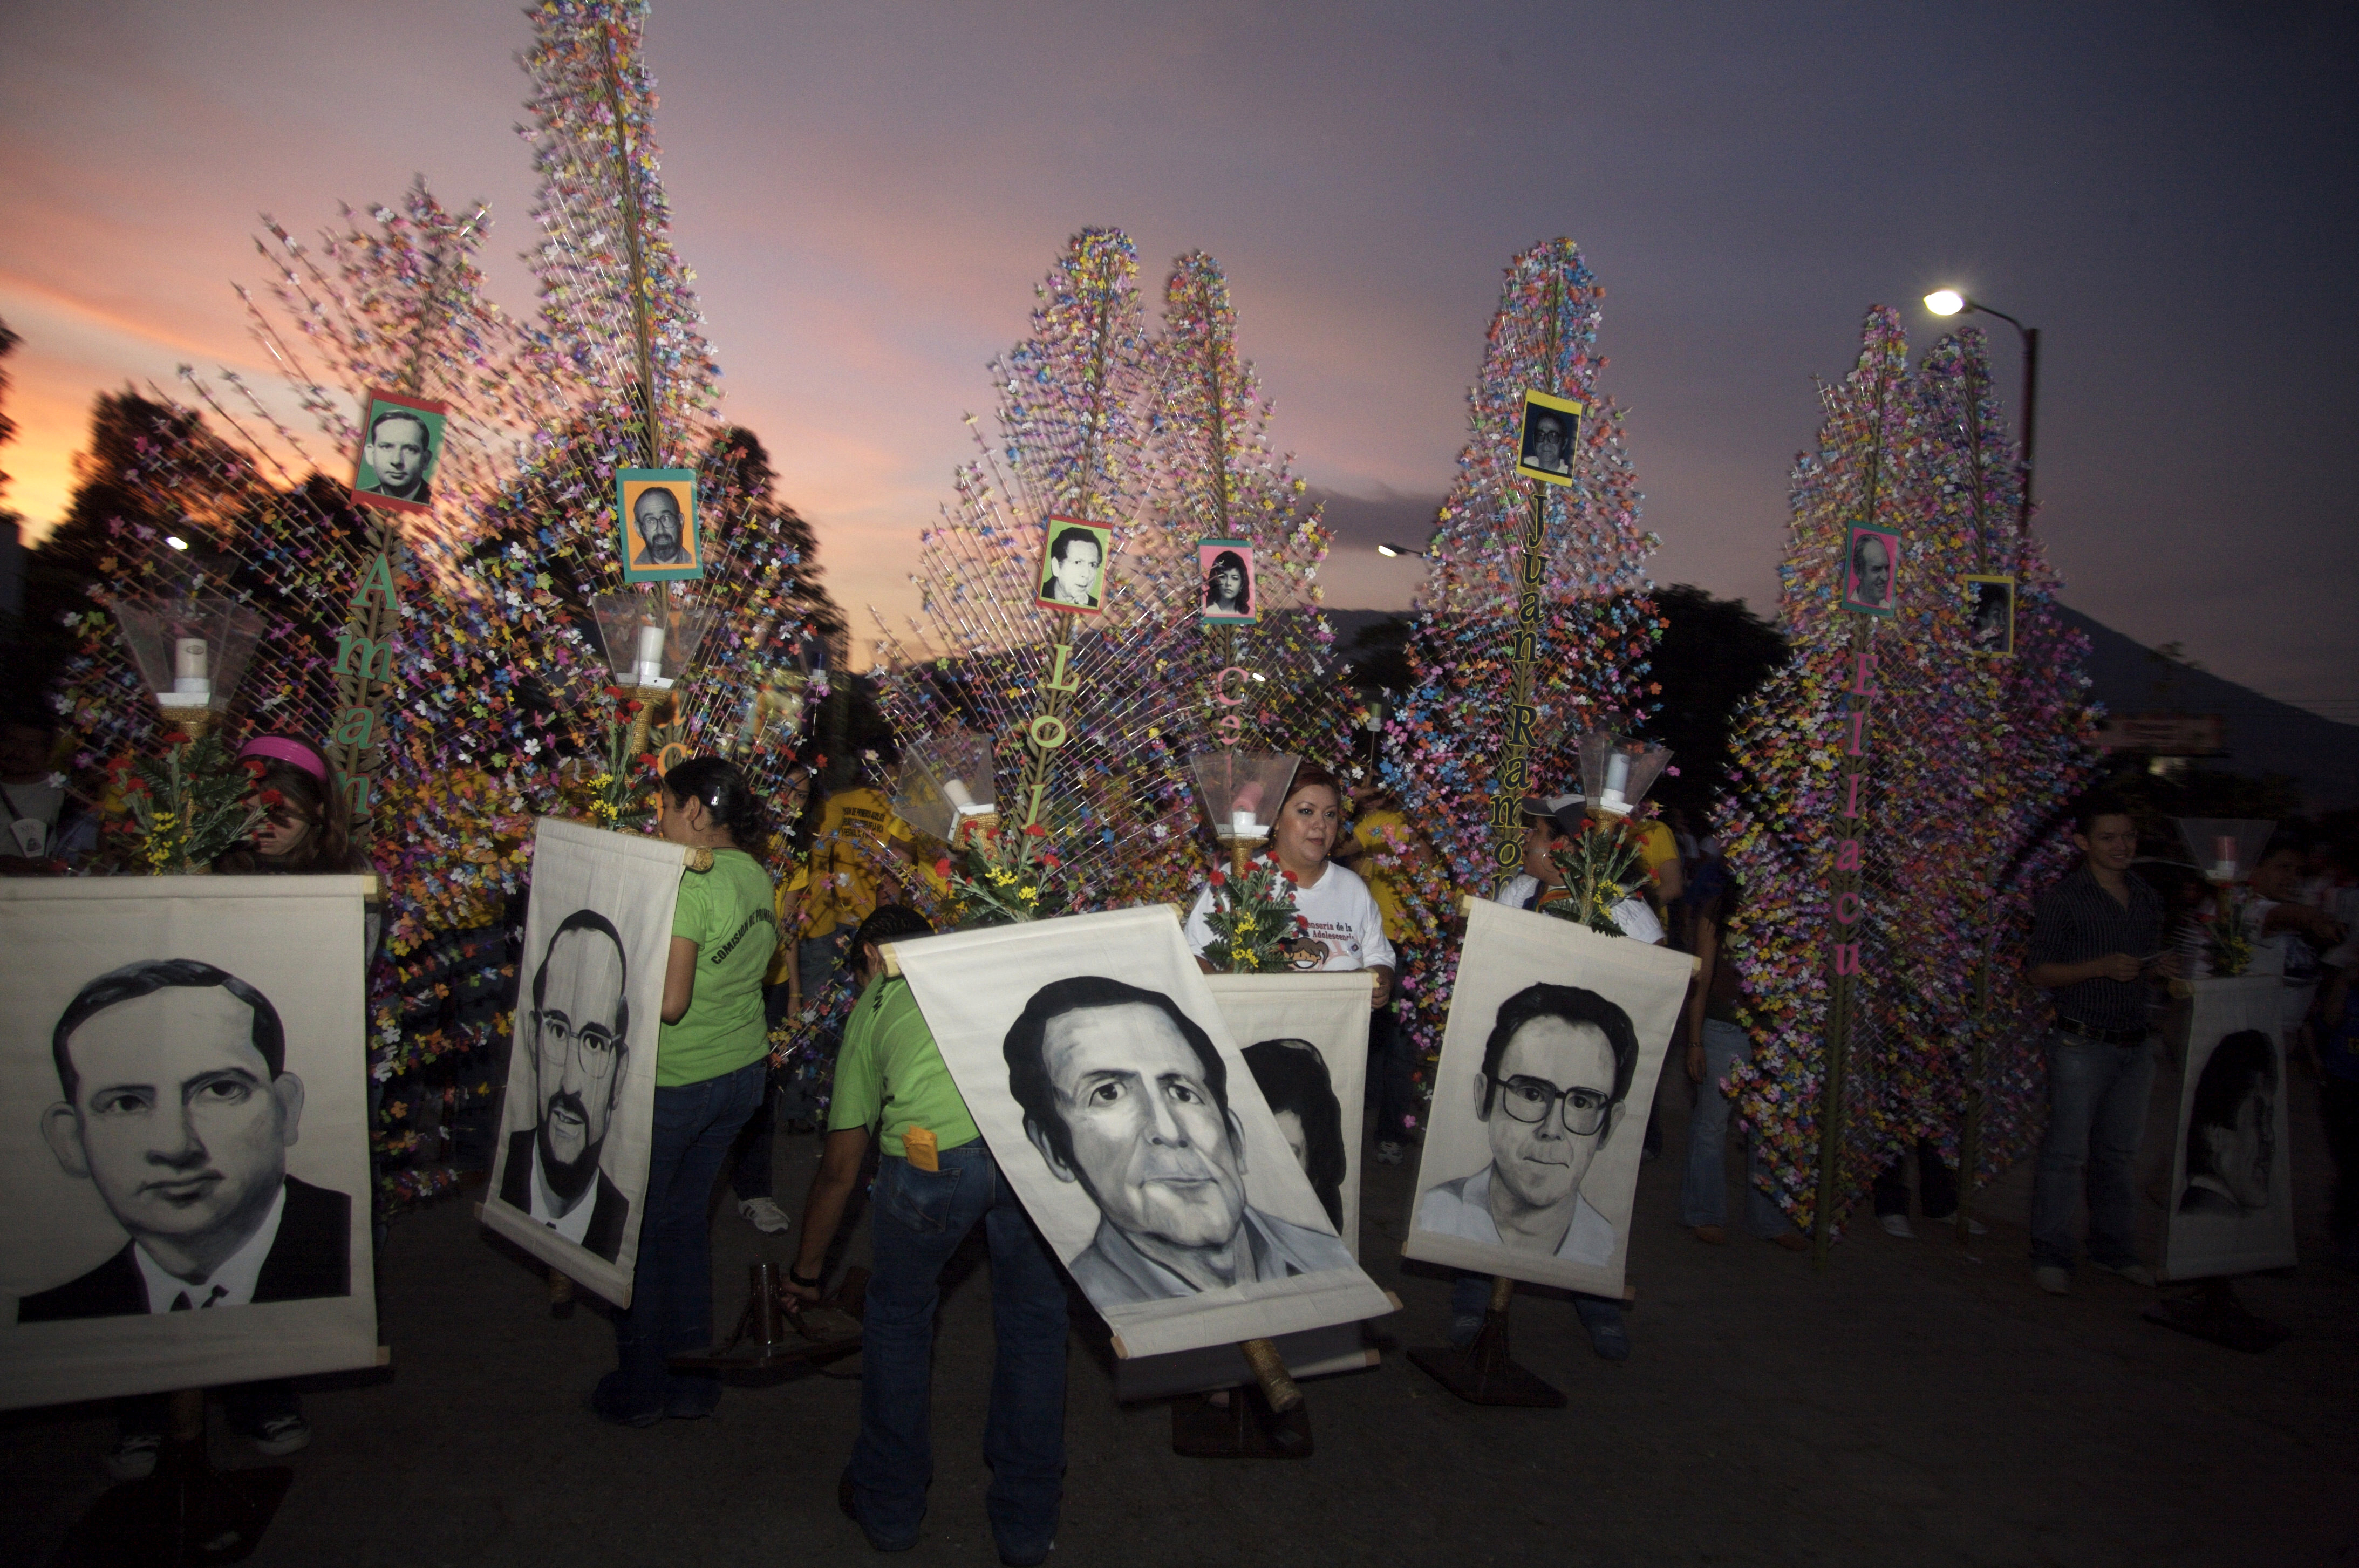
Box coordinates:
[894,905,1392,1356]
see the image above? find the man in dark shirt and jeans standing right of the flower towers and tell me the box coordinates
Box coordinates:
[2024,797,2177,1294]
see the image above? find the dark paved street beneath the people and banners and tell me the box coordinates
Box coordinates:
[0,1051,2359,1568]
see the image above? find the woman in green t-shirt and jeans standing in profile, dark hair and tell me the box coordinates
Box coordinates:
[590,757,779,1427]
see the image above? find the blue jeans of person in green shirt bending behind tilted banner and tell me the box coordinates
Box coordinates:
[844,1141,1066,1559]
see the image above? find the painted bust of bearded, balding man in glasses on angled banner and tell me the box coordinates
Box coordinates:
[500,910,630,1262]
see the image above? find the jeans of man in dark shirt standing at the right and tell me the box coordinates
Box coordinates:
[2031,1031,2154,1269]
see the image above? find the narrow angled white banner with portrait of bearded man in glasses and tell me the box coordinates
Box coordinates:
[483,816,686,1306]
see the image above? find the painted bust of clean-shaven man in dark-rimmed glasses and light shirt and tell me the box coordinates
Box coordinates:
[1418,983,1637,1266]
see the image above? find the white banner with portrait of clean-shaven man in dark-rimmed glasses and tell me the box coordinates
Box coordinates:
[1401,901,1694,1297]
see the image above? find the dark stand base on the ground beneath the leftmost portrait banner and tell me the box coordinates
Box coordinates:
[64,1389,295,1568]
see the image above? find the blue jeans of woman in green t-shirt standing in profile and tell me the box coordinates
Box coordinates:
[599,1056,769,1420]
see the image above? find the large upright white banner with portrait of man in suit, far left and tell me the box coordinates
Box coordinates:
[0,877,378,1408]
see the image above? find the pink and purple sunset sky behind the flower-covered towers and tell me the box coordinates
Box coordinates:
[0,0,2359,719]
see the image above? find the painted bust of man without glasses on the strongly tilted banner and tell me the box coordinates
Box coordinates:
[1003,976,1352,1306]
